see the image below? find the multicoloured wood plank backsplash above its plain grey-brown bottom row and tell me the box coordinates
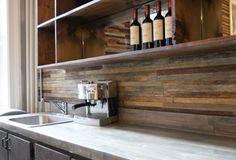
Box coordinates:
[43,52,236,116]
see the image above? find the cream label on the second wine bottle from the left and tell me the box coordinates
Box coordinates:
[142,23,152,43]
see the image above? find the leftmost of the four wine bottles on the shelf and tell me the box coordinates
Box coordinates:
[130,8,141,51]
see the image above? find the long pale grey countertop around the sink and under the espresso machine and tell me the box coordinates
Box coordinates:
[0,115,236,160]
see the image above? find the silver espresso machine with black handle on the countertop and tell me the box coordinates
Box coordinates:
[72,81,118,126]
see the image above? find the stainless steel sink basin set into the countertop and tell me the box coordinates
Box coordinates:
[9,115,72,127]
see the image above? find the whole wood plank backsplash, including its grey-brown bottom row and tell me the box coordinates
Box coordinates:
[43,48,236,137]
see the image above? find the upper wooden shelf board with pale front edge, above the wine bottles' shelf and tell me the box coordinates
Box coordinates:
[38,0,153,28]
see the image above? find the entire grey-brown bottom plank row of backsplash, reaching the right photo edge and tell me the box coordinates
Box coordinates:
[119,108,236,137]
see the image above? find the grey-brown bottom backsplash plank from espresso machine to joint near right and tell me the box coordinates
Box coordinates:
[119,109,214,134]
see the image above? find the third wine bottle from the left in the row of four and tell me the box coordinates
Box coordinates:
[153,0,165,47]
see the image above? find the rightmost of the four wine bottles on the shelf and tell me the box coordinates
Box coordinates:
[165,0,173,45]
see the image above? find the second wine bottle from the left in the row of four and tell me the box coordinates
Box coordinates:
[142,5,153,49]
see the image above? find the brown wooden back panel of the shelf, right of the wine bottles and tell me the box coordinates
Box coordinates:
[175,0,230,43]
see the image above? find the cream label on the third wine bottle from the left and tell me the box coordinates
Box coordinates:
[153,19,164,41]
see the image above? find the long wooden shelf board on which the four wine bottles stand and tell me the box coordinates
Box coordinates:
[37,36,236,69]
